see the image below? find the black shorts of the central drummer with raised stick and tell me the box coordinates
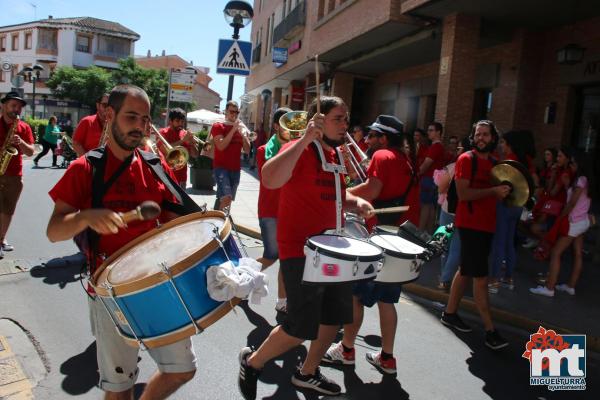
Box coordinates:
[280,257,352,340]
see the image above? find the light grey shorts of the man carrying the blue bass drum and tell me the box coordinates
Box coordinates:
[88,297,196,392]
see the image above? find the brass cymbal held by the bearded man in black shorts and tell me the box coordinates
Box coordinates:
[492,160,534,207]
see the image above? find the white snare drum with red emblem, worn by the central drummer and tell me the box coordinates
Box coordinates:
[302,234,383,285]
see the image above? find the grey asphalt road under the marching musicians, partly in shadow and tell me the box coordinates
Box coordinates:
[0,160,600,400]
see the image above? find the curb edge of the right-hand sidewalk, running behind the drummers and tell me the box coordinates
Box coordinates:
[235,224,600,352]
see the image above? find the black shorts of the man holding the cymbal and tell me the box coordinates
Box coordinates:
[458,228,494,278]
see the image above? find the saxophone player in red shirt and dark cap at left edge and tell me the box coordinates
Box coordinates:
[0,92,34,258]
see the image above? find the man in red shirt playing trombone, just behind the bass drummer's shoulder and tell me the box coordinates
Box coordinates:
[157,108,198,189]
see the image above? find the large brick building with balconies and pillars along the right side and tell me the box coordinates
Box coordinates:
[246,0,600,197]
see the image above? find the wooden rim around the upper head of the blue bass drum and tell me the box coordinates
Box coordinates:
[90,211,231,297]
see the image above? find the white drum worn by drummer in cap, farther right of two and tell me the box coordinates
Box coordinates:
[370,234,427,283]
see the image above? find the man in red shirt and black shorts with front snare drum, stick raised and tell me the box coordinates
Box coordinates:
[238,96,373,400]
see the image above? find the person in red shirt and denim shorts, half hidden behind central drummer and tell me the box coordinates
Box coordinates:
[256,107,292,312]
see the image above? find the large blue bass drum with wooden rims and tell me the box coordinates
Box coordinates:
[91,211,240,348]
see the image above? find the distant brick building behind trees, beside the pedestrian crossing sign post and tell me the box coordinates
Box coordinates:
[135,50,221,111]
